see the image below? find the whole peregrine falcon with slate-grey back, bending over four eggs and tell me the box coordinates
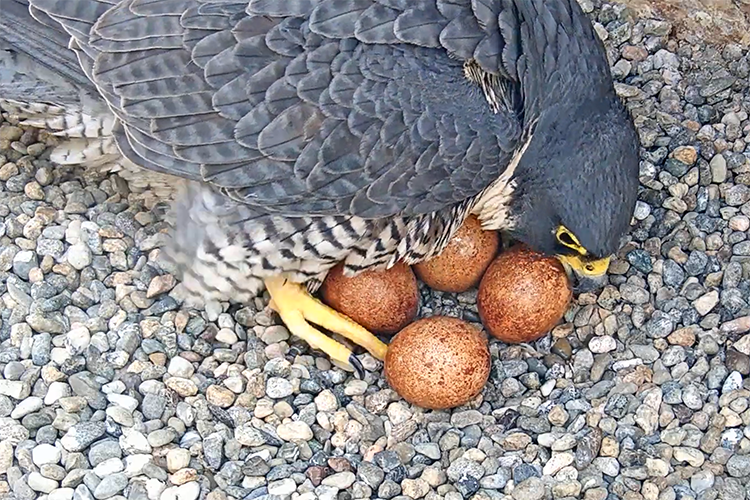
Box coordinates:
[0,0,639,371]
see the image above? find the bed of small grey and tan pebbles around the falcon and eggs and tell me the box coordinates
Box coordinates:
[0,0,750,500]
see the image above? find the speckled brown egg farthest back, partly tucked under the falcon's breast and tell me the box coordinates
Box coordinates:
[414,215,500,293]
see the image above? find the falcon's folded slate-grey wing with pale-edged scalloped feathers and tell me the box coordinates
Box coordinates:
[25,0,538,217]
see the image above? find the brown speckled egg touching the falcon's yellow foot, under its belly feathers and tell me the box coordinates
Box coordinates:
[320,262,419,334]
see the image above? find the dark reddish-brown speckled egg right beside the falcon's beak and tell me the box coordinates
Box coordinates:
[477,245,573,343]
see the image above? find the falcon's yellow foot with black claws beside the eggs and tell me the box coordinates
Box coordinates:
[265,276,388,378]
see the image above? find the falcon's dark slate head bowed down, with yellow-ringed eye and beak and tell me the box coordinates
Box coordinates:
[494,94,639,291]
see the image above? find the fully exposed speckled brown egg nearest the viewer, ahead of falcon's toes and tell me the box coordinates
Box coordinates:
[385,316,490,410]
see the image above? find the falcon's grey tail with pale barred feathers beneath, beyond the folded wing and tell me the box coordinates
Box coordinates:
[0,0,119,166]
